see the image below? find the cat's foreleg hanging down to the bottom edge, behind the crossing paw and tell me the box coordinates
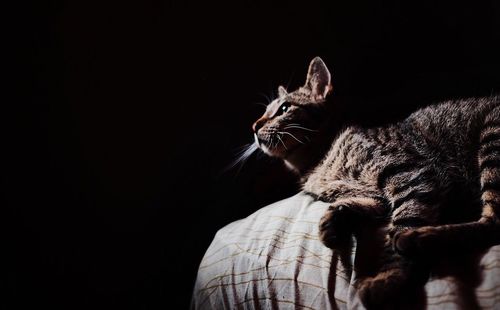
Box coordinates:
[358,194,440,309]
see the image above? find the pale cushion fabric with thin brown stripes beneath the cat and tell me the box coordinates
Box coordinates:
[191,193,500,309]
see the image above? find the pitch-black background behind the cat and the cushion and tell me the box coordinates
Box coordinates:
[6,0,500,309]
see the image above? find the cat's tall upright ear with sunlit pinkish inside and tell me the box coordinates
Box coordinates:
[304,57,332,100]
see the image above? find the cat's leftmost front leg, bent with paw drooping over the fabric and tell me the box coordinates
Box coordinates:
[319,197,388,249]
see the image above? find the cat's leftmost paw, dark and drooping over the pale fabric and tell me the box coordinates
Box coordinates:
[319,205,355,249]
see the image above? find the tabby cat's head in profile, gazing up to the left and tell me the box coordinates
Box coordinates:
[252,57,332,170]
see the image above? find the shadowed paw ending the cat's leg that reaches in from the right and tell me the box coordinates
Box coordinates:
[392,227,436,256]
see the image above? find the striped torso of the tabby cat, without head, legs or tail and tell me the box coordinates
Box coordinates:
[303,97,500,224]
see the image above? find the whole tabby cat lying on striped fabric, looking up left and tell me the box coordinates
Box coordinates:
[252,57,500,309]
